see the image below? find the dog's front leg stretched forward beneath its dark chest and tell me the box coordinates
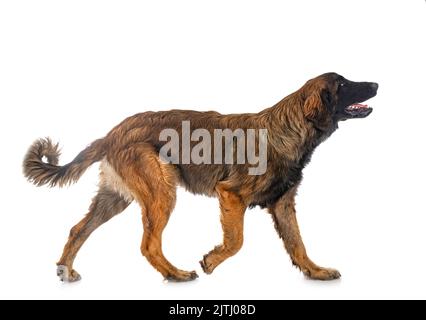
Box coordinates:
[269,187,340,280]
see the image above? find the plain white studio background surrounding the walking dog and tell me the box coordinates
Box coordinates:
[0,0,426,299]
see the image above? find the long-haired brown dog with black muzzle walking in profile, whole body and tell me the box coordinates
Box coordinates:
[23,73,378,282]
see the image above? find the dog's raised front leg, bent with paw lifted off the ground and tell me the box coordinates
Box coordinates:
[200,184,246,274]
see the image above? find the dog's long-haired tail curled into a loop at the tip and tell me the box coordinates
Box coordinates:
[23,138,105,187]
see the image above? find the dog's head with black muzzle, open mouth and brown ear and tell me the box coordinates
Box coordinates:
[301,73,379,130]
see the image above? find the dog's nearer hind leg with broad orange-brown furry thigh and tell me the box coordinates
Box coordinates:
[117,144,197,281]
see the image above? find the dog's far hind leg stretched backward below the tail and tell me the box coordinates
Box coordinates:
[57,185,131,282]
